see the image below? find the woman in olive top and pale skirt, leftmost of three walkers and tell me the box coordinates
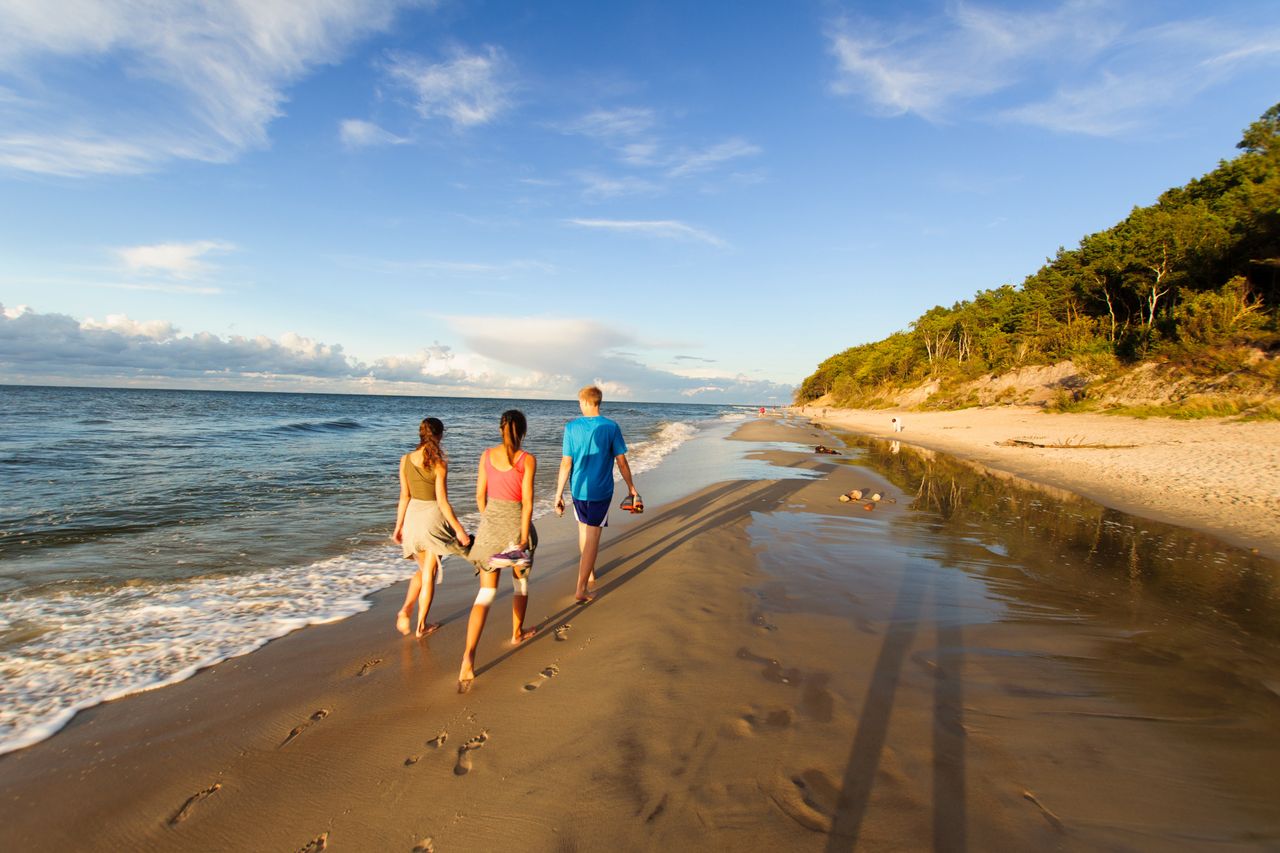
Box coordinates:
[392,418,471,637]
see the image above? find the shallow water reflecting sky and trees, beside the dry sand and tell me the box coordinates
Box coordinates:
[750,437,1280,850]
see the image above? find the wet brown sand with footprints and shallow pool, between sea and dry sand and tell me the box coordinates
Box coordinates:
[0,420,1280,850]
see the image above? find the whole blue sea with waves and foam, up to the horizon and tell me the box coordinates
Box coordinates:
[0,387,746,753]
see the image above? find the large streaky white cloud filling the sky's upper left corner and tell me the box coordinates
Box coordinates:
[0,0,413,177]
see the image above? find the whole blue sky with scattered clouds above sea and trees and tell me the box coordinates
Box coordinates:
[0,0,1280,405]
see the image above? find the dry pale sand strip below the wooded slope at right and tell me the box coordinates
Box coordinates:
[797,406,1280,558]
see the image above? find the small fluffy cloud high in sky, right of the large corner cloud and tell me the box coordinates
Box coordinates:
[387,46,515,128]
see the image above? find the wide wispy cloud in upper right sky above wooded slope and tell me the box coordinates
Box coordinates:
[828,0,1280,134]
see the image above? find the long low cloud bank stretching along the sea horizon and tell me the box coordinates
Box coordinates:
[0,305,792,403]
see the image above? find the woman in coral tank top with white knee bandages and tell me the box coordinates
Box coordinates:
[458,409,538,693]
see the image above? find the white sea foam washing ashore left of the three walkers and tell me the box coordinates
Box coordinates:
[0,548,408,753]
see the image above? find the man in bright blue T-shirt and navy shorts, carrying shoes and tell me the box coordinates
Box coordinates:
[556,386,644,605]
